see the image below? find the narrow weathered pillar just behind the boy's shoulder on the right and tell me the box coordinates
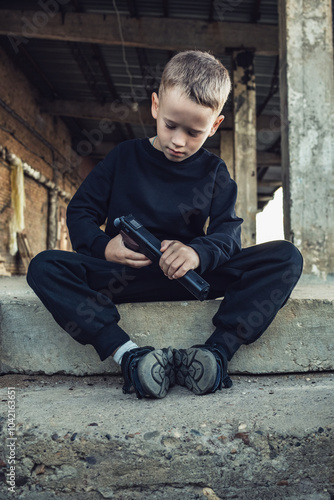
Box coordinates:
[233,50,257,247]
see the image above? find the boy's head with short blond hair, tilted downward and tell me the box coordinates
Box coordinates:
[152,51,231,162]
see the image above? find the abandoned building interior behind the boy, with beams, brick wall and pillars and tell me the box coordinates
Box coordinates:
[0,0,334,278]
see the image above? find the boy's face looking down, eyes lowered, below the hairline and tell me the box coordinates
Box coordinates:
[152,87,224,162]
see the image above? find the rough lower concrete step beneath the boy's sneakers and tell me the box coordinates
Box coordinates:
[0,373,334,500]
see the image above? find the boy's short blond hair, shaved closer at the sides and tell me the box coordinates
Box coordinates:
[159,50,231,112]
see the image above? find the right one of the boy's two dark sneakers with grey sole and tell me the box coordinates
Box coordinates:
[173,344,232,395]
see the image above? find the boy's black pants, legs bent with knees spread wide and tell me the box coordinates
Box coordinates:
[27,241,303,360]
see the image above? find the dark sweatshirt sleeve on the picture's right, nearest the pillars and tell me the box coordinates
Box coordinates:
[189,167,243,273]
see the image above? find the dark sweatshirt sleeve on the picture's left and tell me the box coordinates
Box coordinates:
[67,155,112,259]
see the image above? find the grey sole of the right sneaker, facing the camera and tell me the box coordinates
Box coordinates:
[174,347,217,395]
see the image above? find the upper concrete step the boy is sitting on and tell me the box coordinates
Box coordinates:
[0,277,334,375]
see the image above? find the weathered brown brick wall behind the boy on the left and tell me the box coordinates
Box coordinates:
[0,48,93,274]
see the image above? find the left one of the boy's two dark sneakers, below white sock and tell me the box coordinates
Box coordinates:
[121,346,175,399]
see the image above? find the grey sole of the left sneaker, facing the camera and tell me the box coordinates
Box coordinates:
[138,348,175,399]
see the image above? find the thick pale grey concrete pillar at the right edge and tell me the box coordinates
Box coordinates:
[279,0,334,278]
